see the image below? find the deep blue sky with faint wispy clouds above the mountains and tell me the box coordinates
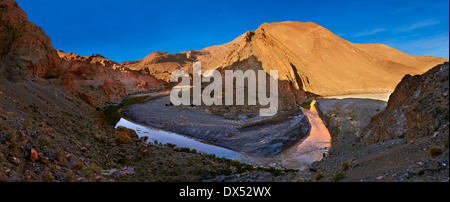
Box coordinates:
[16,0,449,62]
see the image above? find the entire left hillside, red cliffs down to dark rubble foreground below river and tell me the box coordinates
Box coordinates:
[0,0,306,182]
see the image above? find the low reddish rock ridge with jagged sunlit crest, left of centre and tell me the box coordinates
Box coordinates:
[58,51,165,107]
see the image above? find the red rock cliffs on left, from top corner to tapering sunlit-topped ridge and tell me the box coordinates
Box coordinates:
[0,0,165,107]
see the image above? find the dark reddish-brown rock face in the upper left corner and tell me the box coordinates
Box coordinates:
[0,0,61,81]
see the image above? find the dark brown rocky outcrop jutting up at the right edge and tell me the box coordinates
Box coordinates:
[366,62,449,144]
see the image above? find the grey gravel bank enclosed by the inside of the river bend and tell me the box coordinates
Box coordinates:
[122,96,310,156]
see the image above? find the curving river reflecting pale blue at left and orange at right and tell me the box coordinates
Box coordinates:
[116,98,331,170]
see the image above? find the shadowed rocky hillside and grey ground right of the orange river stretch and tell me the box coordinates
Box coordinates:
[314,62,449,182]
